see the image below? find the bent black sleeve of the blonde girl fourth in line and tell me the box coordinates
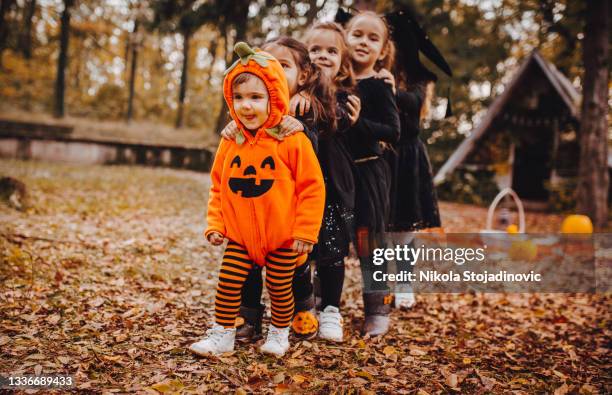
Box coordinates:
[354,85,400,144]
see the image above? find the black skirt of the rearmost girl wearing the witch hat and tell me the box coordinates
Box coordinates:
[385,136,440,232]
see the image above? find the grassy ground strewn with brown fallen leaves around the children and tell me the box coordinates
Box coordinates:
[0,160,612,394]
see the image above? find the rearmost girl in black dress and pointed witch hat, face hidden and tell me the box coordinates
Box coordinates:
[379,8,452,308]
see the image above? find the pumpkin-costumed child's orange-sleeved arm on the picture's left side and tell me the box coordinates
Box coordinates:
[204,139,228,244]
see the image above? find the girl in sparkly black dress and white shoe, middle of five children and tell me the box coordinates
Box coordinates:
[304,22,361,342]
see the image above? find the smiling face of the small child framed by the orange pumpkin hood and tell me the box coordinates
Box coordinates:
[232,73,269,131]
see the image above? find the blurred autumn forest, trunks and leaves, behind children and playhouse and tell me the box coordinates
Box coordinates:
[0,0,609,213]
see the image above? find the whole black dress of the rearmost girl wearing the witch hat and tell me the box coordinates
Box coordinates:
[385,84,440,232]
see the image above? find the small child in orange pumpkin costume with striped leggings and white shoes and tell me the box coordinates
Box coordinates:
[190,43,325,356]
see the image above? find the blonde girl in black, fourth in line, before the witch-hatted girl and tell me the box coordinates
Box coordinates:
[347,12,400,336]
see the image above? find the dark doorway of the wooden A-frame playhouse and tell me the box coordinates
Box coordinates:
[512,130,551,201]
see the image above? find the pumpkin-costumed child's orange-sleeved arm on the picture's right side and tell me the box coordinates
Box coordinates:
[286,133,325,243]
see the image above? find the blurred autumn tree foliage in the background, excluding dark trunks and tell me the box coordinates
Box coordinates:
[0,0,583,148]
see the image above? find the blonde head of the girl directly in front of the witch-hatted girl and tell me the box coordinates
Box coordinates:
[347,15,387,72]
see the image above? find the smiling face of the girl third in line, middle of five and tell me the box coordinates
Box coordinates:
[307,29,342,80]
